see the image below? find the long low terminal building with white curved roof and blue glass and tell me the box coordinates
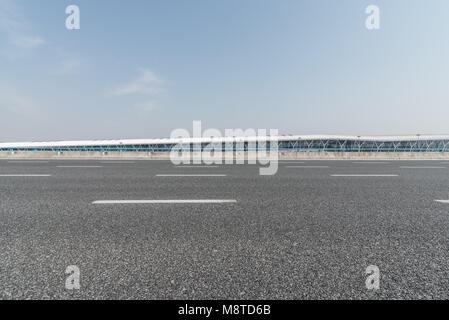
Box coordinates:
[0,135,449,153]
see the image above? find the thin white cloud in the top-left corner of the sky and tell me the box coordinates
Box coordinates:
[0,0,45,59]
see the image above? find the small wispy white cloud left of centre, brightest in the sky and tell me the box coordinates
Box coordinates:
[112,69,164,96]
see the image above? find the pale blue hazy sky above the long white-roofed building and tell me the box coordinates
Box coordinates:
[0,0,449,141]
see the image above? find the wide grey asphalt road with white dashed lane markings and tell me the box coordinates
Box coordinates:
[0,160,449,299]
